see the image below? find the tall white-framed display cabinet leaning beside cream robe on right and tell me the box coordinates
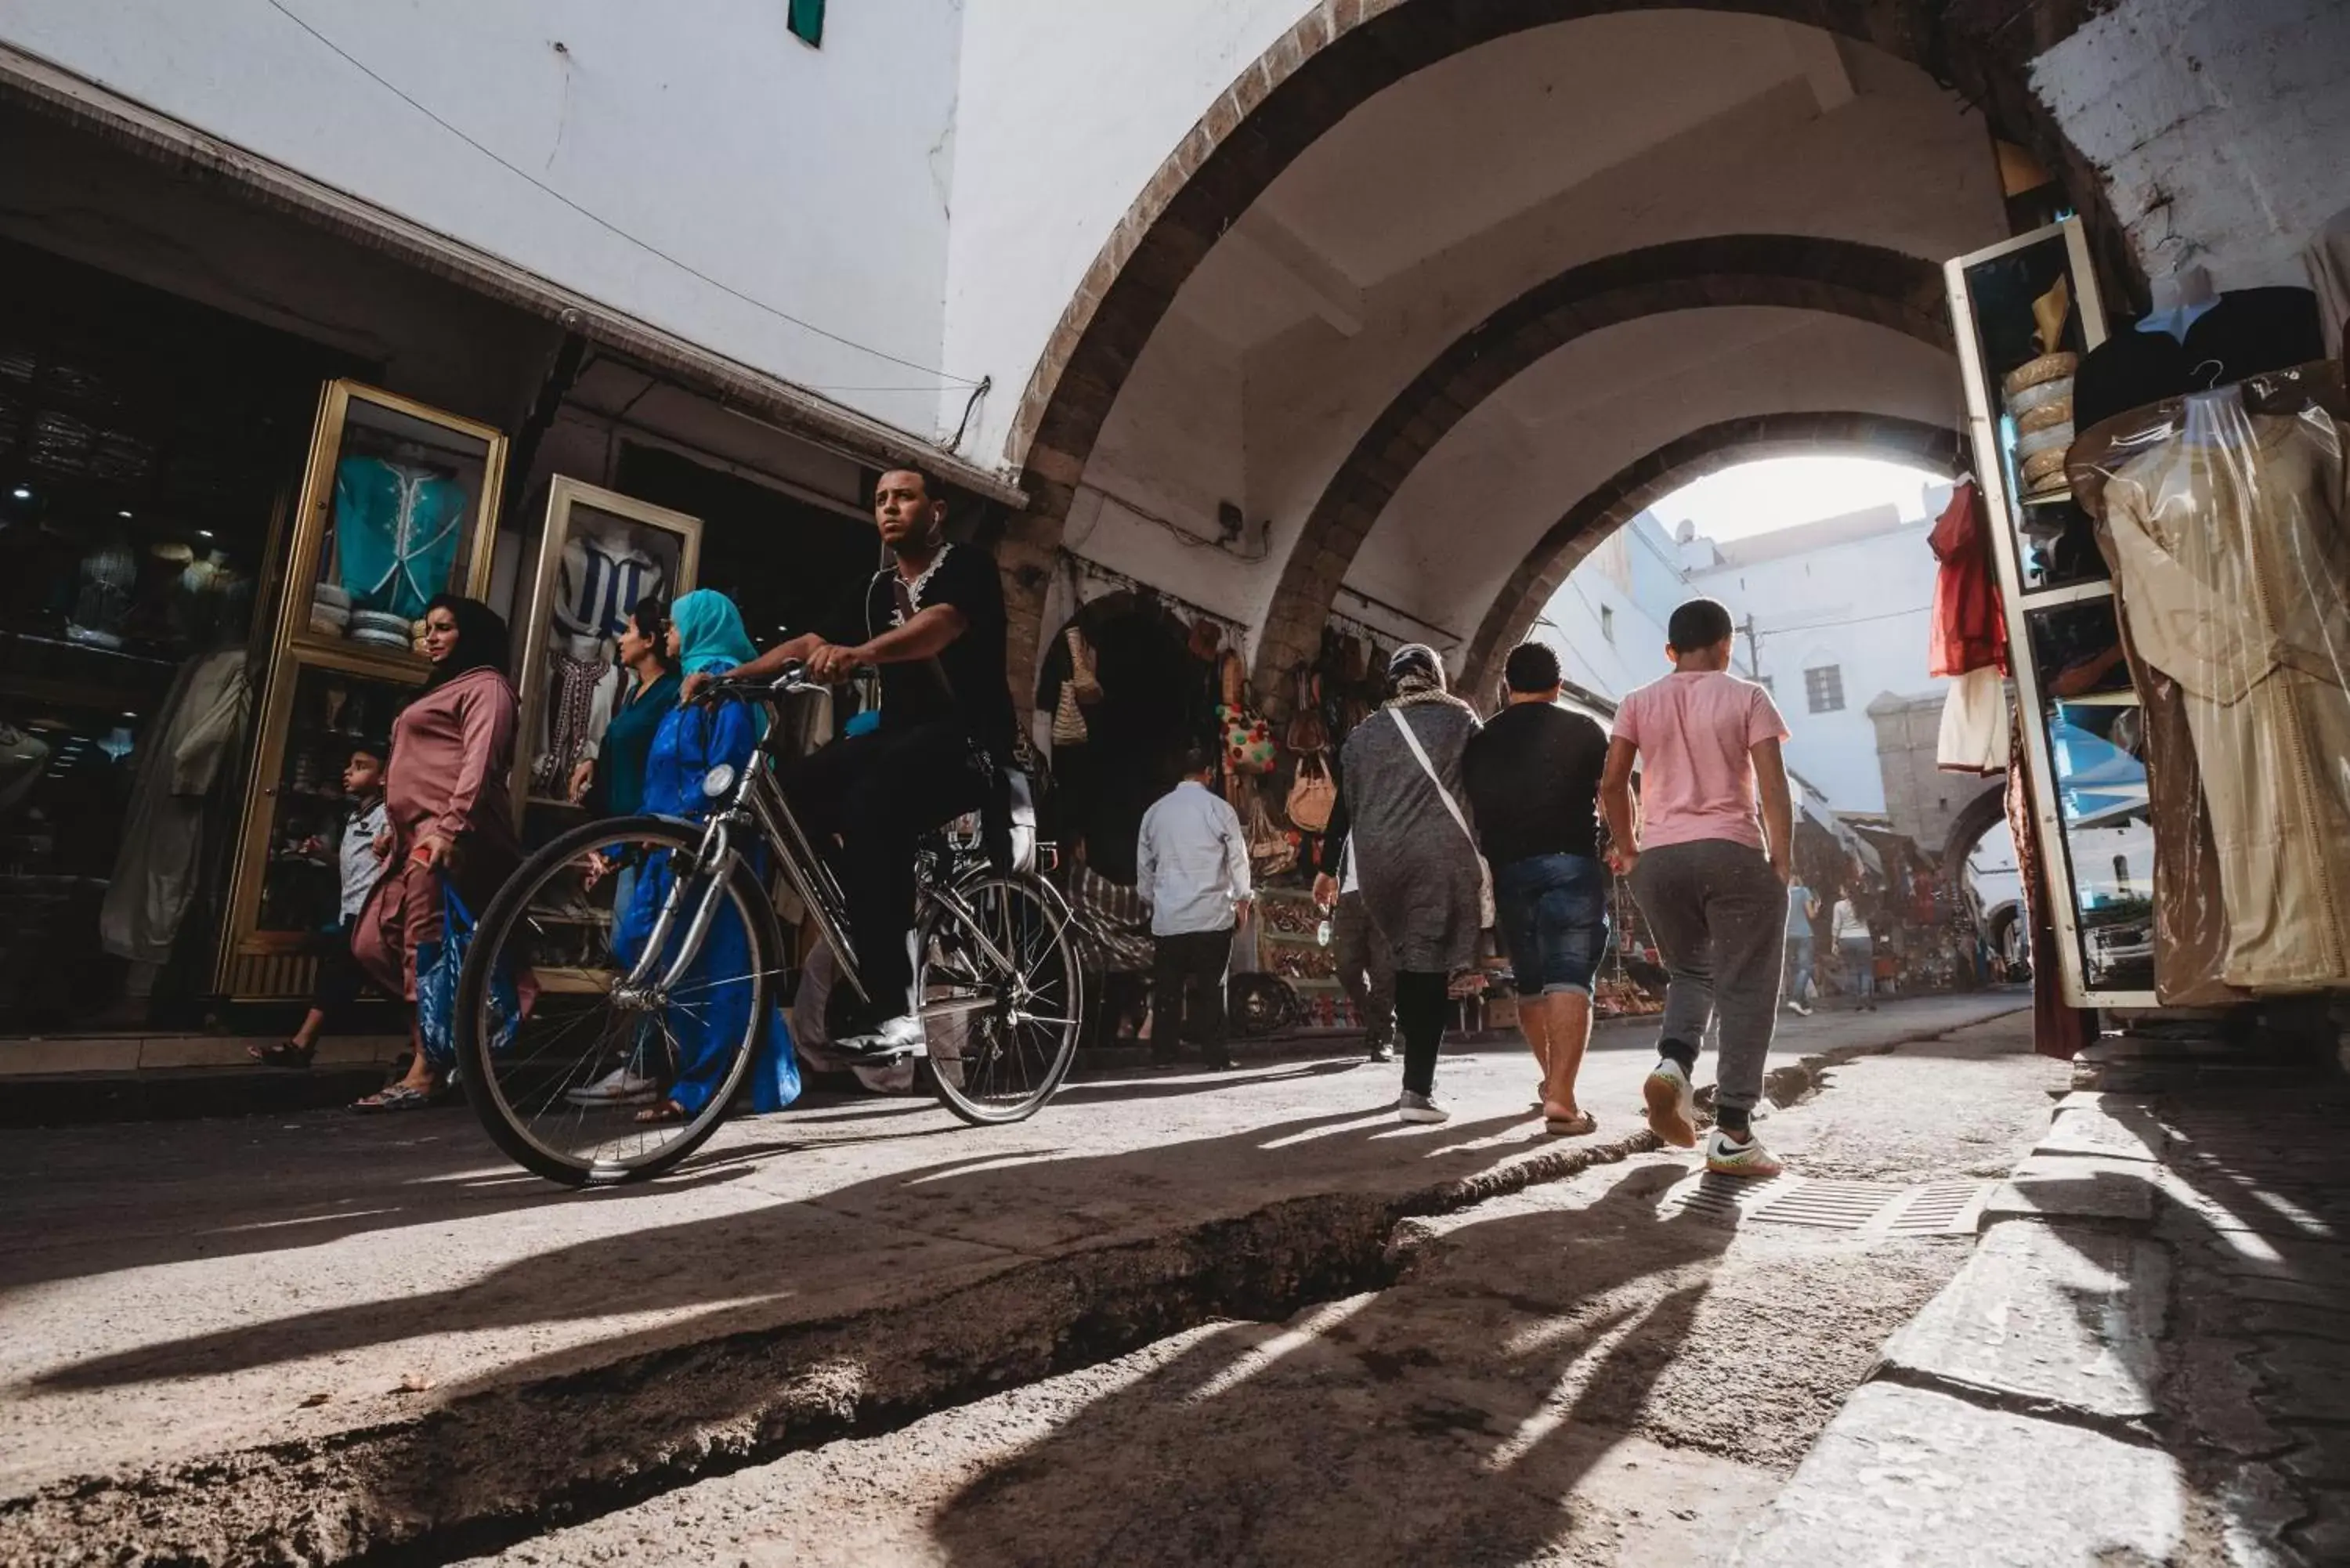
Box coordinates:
[1943,219,2155,1006]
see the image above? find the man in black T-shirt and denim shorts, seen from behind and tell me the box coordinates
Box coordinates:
[1462,641,1607,1138]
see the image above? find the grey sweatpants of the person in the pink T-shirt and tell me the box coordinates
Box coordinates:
[1631,840,1786,1110]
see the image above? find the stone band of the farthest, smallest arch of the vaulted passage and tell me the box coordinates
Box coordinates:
[1462,414,1962,691]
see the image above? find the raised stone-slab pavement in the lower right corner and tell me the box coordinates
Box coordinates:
[1732,1079,2350,1568]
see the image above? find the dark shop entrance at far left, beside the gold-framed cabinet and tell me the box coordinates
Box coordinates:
[0,242,352,1032]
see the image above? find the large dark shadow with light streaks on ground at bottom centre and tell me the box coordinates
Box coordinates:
[931,1166,1739,1568]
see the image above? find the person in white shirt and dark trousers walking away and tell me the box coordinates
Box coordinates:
[1135,740,1250,1068]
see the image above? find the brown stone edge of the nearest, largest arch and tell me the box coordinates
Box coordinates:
[999,0,2143,691]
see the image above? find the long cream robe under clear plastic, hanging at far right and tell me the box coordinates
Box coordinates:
[2106,404,2350,990]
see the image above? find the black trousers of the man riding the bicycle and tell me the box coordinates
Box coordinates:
[783,721,989,1018]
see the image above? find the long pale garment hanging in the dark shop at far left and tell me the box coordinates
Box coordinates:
[99,649,251,964]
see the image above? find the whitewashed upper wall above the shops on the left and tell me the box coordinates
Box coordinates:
[0,0,964,435]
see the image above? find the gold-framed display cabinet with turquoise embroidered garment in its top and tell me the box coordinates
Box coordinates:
[219,392,505,1002]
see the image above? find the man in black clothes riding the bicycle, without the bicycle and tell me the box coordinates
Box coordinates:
[686,468,1013,1053]
